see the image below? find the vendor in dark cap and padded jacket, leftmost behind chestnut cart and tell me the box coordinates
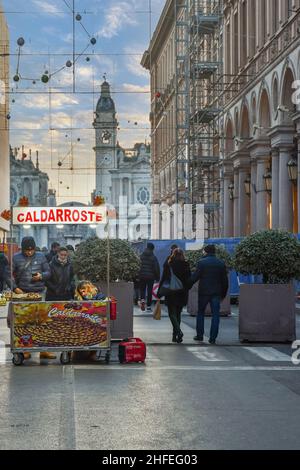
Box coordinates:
[13,237,50,294]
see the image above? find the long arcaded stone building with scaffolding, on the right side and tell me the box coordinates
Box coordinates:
[142,0,300,238]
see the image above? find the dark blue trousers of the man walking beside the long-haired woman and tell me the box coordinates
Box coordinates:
[197,295,221,341]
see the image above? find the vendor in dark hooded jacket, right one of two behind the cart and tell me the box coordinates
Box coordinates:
[46,247,75,301]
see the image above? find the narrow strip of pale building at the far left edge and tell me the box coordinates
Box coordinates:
[0,3,10,242]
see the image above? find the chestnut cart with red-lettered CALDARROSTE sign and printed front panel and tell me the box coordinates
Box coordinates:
[8,206,115,366]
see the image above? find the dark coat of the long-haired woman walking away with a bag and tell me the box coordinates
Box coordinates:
[158,260,191,307]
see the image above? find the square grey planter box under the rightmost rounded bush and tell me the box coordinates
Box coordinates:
[239,284,296,343]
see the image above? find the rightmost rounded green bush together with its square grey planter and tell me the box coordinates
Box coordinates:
[234,230,300,342]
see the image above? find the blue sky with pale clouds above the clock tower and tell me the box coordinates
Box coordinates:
[2,0,165,203]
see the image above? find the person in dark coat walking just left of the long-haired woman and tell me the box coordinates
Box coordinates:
[139,243,160,311]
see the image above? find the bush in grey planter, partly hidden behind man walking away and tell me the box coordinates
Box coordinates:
[186,245,233,316]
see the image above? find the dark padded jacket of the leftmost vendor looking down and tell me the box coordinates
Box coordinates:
[13,252,51,292]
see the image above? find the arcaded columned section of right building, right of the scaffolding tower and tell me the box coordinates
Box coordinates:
[222,0,300,237]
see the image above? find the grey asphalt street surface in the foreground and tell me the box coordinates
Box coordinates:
[0,306,300,450]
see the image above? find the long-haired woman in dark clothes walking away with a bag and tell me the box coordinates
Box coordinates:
[158,248,191,343]
